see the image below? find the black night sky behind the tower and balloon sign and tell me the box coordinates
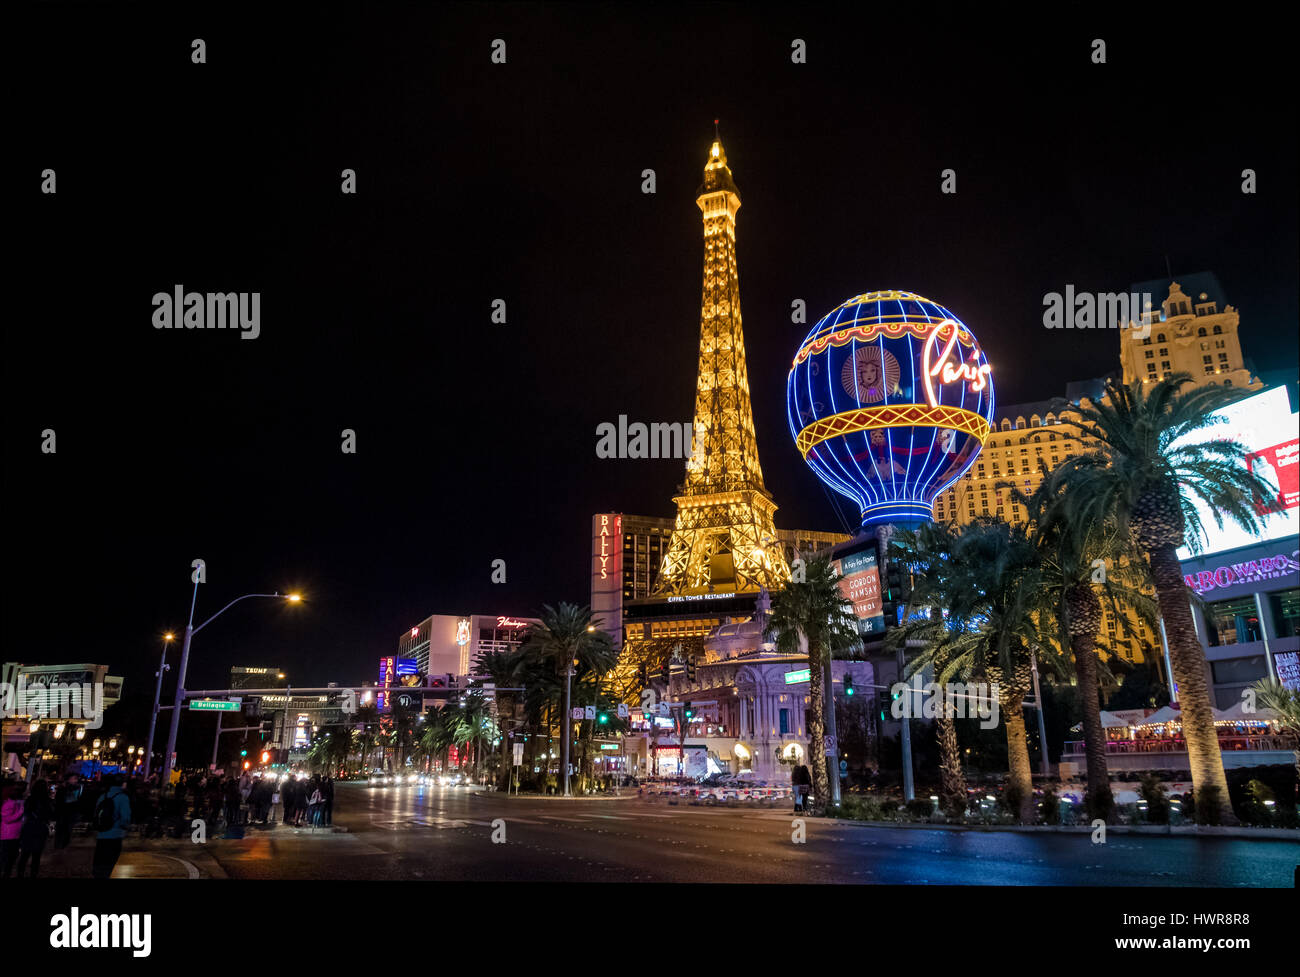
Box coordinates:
[4,5,1300,748]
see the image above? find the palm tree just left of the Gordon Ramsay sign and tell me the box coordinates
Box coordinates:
[767,556,862,809]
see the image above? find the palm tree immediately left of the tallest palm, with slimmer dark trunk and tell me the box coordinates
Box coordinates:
[1009,473,1157,821]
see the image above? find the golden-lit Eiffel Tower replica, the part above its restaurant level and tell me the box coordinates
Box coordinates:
[655,129,789,595]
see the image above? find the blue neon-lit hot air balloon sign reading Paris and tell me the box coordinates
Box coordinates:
[785,291,993,529]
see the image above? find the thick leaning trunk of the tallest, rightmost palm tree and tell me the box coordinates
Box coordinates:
[1148,544,1238,825]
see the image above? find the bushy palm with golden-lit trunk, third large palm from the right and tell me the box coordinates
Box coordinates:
[885,518,1060,822]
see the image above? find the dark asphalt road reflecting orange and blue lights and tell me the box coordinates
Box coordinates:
[192,785,1300,887]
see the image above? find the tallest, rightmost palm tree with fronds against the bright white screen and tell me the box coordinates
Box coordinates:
[1058,373,1277,824]
